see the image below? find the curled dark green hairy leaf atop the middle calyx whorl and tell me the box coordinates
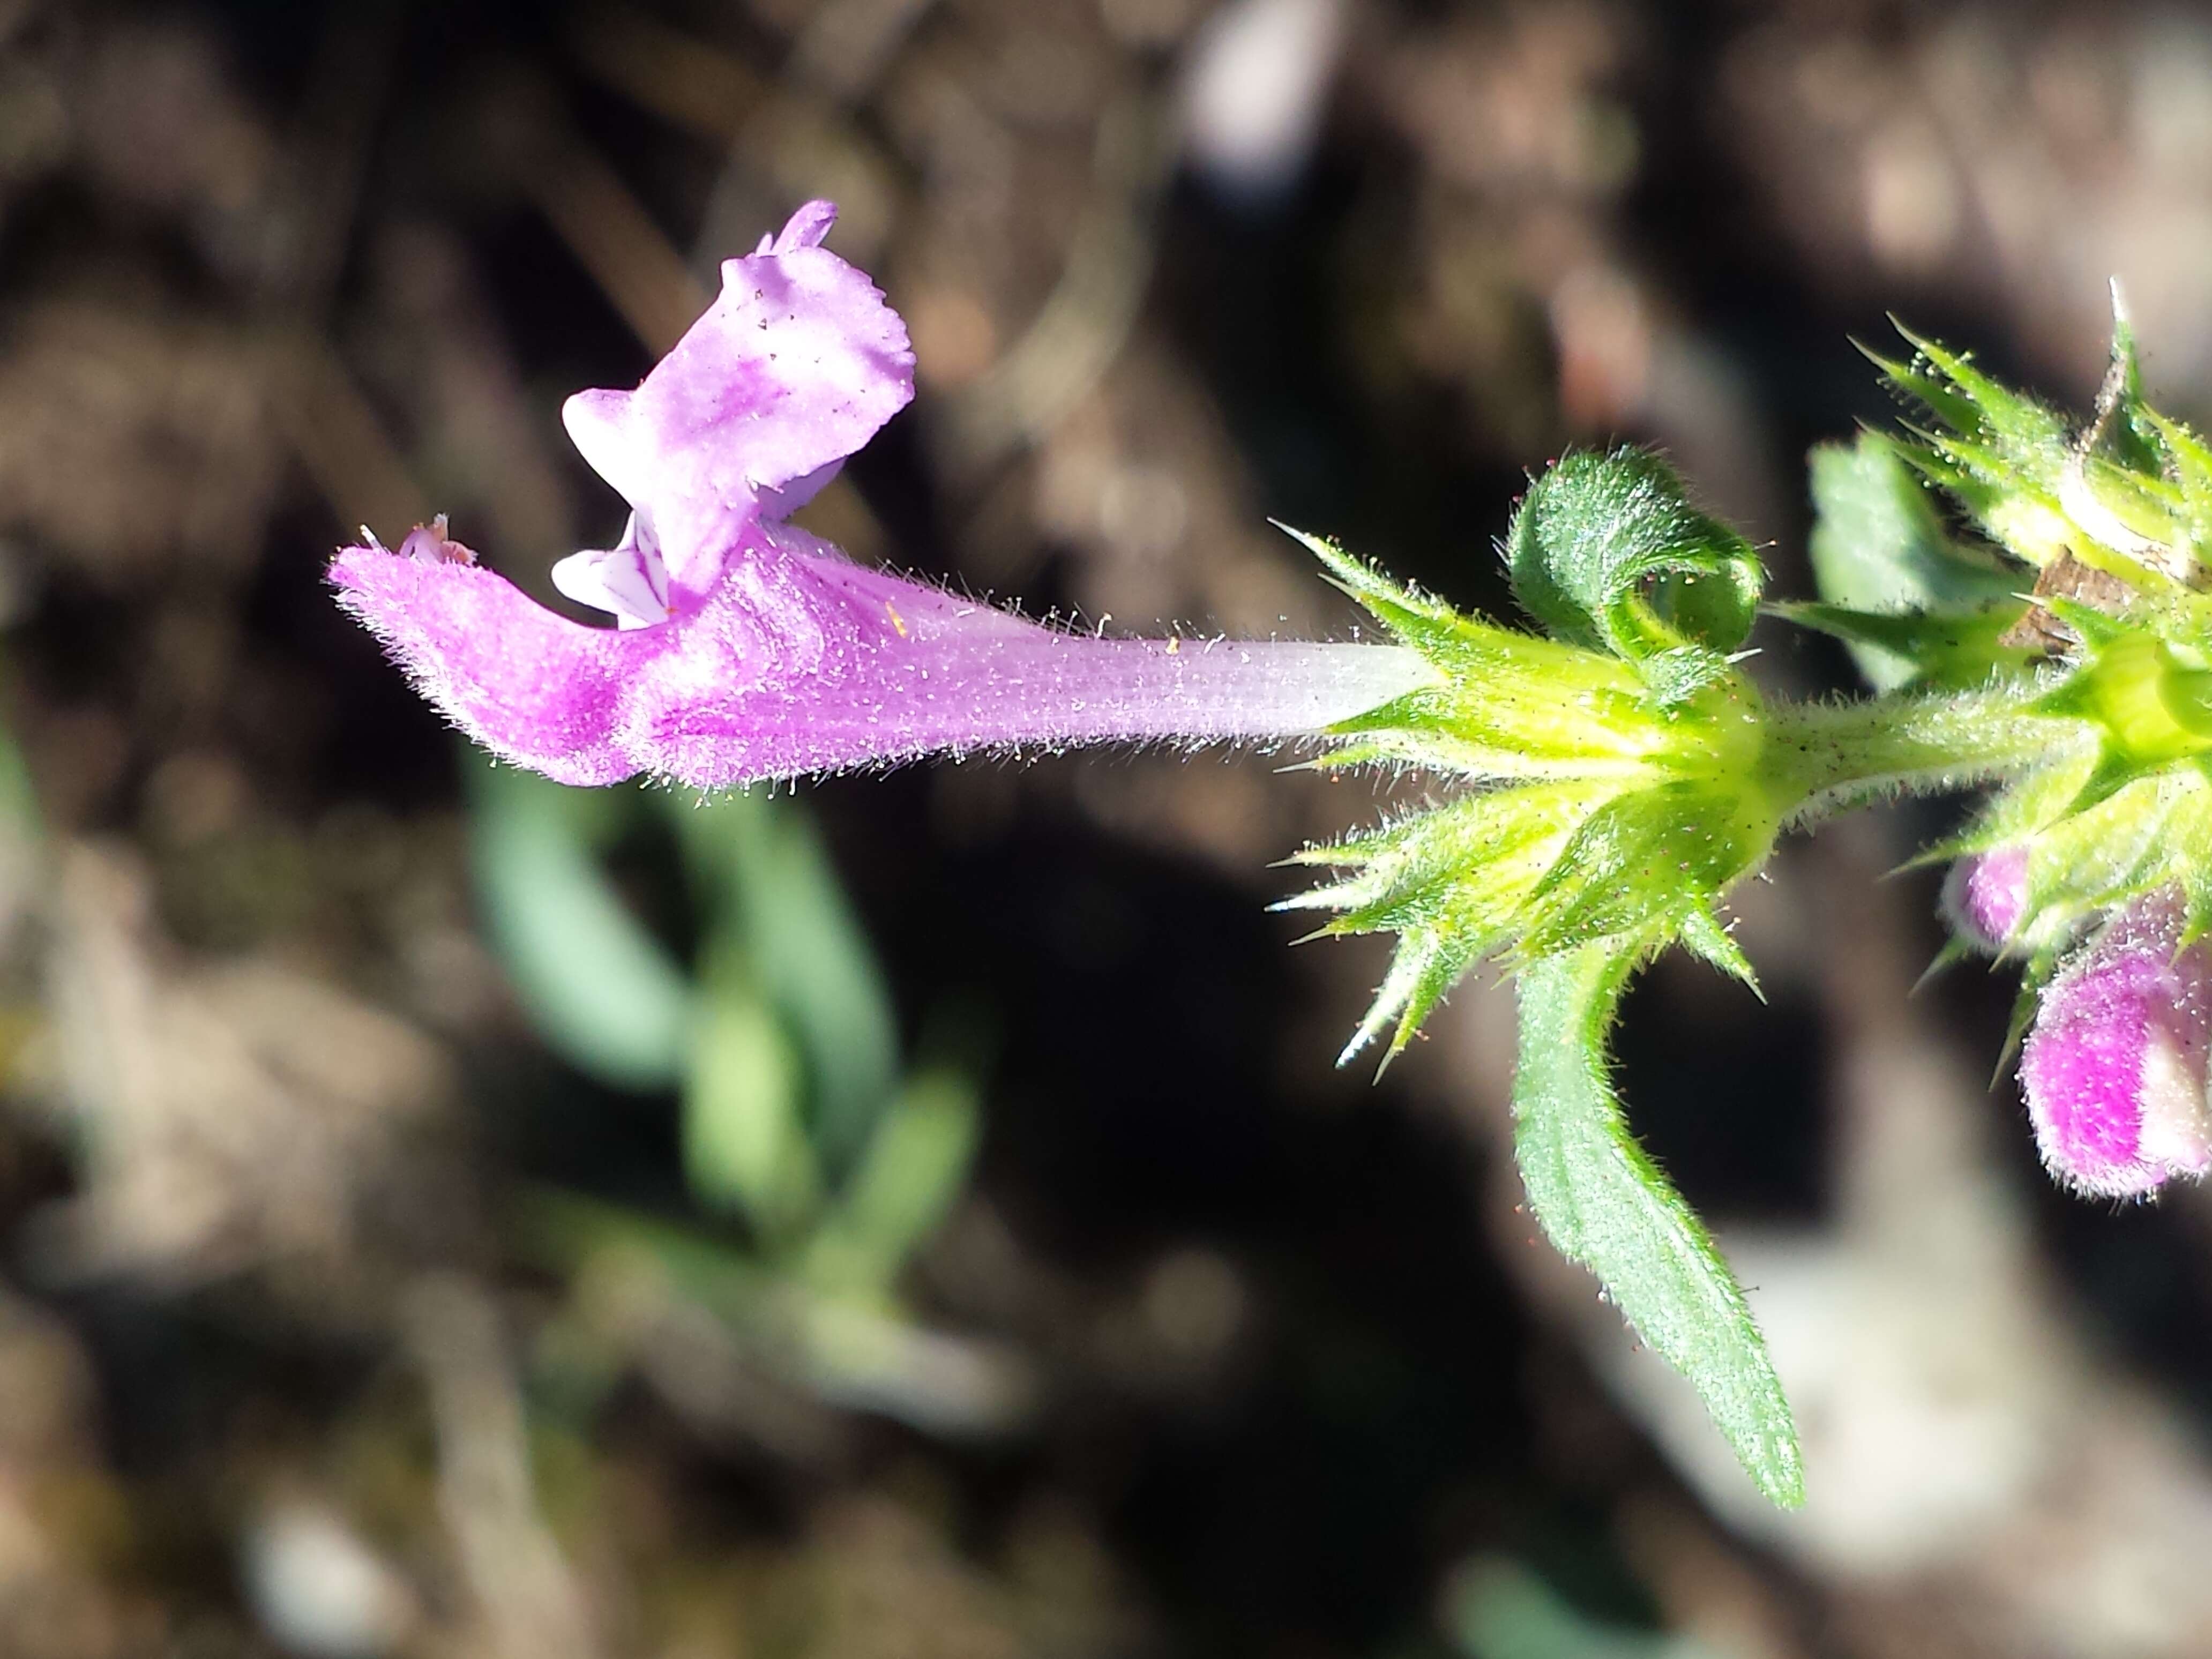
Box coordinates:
[1506,449,1765,661]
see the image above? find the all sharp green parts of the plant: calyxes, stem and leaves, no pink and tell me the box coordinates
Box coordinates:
[1283,316,2212,1504]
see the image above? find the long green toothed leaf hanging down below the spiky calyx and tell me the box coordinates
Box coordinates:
[1513,940,1805,1506]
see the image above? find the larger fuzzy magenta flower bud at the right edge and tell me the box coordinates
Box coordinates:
[2020,894,2212,1199]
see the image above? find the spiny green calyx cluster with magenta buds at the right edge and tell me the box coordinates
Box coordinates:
[1891,314,2212,1199]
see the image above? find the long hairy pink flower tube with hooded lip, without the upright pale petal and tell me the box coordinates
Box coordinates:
[332,524,1431,788]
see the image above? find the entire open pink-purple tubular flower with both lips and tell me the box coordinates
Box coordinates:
[330,201,1429,788]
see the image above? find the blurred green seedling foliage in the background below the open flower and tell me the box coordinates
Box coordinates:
[471,763,995,1420]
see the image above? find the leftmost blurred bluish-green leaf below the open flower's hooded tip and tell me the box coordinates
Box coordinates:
[469,761,692,1090]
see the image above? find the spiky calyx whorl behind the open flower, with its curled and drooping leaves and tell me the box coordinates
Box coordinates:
[1283,451,1803,1504]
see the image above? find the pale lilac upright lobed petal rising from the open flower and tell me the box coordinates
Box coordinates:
[562,201,914,597]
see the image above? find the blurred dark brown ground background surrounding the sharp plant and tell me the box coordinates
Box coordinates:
[0,0,2212,1659]
